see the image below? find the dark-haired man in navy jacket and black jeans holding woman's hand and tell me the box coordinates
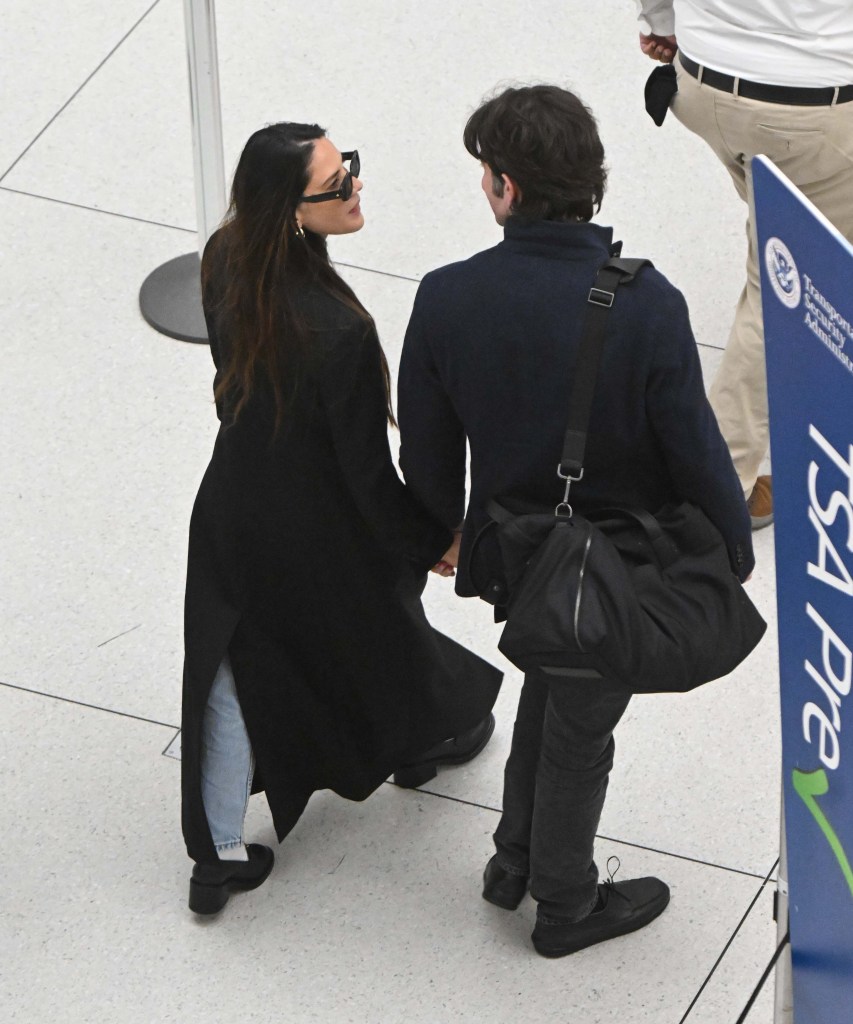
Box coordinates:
[398,85,753,956]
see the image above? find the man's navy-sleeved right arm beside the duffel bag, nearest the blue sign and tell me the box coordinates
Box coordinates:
[646,286,755,581]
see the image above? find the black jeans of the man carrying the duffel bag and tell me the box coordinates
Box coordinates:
[495,674,631,921]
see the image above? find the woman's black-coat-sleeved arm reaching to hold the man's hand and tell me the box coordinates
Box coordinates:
[319,318,453,571]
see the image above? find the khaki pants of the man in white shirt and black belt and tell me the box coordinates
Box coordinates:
[672,60,853,497]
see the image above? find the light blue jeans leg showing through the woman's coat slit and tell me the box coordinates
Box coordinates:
[202,654,255,853]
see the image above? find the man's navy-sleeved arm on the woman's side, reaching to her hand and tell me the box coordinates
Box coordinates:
[397,282,466,529]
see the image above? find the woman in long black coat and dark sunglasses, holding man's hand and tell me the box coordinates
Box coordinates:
[182,124,501,913]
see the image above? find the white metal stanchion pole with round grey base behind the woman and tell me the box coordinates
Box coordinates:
[139,0,226,342]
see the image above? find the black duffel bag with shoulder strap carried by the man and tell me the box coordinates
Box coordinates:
[468,259,767,693]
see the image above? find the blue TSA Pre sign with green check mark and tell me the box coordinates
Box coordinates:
[753,157,853,1024]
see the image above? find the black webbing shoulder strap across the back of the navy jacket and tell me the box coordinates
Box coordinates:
[559,257,652,480]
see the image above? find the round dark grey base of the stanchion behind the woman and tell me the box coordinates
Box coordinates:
[139,252,208,345]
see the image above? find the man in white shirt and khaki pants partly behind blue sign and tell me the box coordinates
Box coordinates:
[637,0,853,529]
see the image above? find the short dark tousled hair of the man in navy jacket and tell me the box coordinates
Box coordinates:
[463,85,607,220]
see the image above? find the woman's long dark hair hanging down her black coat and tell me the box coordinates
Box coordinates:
[202,122,396,432]
